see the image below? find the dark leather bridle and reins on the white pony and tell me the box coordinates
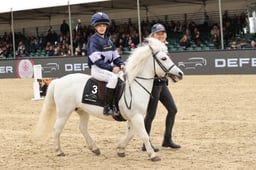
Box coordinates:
[124,45,175,110]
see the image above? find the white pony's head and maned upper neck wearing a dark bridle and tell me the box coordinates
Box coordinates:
[126,38,183,81]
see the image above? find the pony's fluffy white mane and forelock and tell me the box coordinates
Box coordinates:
[125,38,166,81]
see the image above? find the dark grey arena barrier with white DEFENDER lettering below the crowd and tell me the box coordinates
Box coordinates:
[0,49,256,79]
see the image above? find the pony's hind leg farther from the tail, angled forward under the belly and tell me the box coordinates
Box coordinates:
[76,110,100,155]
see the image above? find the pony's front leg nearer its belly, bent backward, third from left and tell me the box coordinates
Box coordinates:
[117,121,134,157]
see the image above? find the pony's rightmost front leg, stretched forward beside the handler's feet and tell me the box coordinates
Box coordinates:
[131,113,161,161]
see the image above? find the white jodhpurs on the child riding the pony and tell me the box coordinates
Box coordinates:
[91,65,118,89]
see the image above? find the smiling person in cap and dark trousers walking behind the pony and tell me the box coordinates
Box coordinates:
[142,23,180,151]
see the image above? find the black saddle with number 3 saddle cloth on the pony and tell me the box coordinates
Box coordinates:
[82,78,126,121]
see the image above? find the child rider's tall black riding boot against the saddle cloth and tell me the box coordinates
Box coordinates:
[103,88,115,115]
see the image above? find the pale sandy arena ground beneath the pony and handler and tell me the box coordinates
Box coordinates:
[0,75,256,170]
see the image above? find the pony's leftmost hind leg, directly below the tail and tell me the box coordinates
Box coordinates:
[54,107,72,156]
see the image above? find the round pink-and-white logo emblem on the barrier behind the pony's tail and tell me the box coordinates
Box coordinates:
[16,59,34,78]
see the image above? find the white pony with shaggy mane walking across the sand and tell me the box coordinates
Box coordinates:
[35,38,183,161]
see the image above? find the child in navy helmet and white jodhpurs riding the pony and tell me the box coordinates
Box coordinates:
[87,12,124,115]
